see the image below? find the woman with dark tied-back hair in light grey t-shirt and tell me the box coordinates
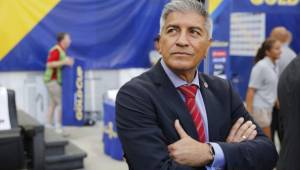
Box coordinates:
[246,38,281,139]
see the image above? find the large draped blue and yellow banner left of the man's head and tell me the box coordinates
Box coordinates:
[0,0,168,71]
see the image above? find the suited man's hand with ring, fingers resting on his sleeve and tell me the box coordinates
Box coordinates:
[226,117,257,143]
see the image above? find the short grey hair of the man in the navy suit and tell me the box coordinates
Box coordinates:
[159,0,213,38]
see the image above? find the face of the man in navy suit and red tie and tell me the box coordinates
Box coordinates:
[159,12,211,72]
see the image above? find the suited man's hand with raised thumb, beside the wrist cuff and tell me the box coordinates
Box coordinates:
[168,120,213,167]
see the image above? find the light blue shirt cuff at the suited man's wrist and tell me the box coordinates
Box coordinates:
[207,142,225,170]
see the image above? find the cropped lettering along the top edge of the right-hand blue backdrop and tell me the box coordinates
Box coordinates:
[250,0,300,6]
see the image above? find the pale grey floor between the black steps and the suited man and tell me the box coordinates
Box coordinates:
[65,123,128,170]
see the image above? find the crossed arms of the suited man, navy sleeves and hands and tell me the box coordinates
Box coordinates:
[116,83,277,170]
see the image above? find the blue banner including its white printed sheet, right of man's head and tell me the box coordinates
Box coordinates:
[209,0,300,99]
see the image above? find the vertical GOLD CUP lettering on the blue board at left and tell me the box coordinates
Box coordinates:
[75,66,83,120]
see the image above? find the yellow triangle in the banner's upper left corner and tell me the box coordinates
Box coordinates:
[0,0,60,61]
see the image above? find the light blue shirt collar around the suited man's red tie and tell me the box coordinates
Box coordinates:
[160,59,200,88]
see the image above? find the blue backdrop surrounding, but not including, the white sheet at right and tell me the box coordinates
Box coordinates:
[210,0,300,98]
